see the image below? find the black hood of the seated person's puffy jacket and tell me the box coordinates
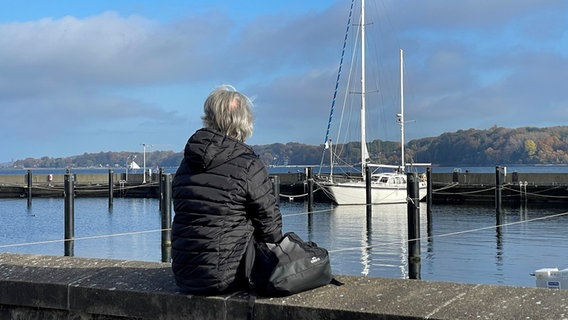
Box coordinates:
[184,128,254,171]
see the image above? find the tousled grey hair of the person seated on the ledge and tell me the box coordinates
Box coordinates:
[201,85,254,142]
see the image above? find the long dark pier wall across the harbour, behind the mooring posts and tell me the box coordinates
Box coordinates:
[0,172,568,204]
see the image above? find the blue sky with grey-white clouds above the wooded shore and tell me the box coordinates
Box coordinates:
[0,0,568,163]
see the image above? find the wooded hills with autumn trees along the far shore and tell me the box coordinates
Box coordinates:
[10,126,568,168]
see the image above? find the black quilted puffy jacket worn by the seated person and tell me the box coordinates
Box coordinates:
[172,129,282,294]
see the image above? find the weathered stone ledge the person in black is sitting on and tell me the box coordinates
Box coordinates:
[0,253,568,320]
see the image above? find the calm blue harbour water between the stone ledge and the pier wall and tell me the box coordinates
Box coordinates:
[0,198,568,287]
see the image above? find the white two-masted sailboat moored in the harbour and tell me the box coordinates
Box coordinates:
[319,0,427,205]
